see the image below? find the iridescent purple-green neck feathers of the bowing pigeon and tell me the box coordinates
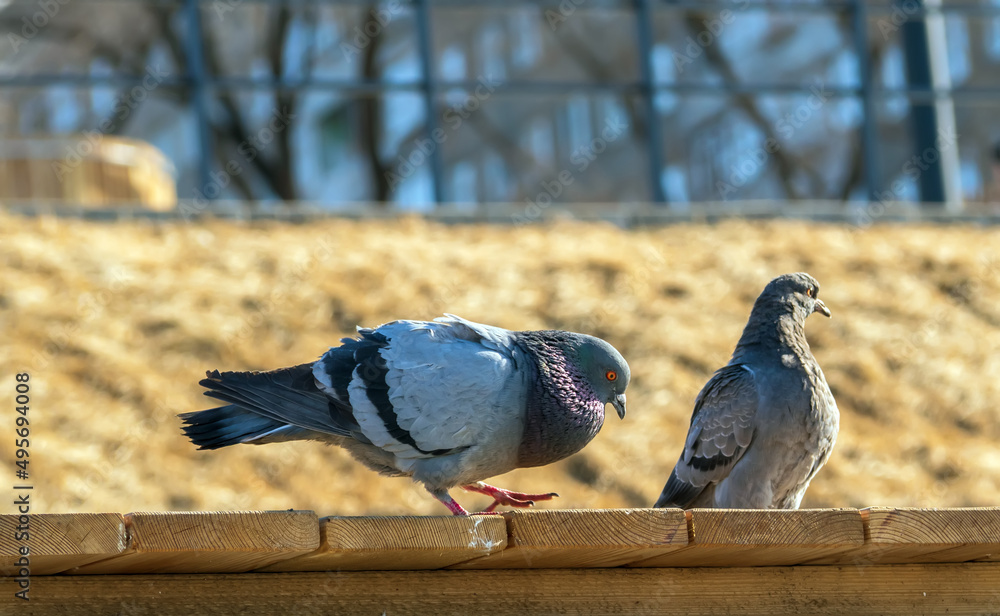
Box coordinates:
[517,332,605,467]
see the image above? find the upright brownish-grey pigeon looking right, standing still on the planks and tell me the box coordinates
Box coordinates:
[654,273,840,509]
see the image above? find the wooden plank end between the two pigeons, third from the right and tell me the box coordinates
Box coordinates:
[455,509,688,569]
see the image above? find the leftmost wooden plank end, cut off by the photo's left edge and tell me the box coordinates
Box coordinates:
[0,513,128,575]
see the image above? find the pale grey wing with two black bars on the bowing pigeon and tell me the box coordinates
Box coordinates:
[313,316,525,459]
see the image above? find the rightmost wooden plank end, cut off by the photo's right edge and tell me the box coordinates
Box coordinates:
[810,507,1000,566]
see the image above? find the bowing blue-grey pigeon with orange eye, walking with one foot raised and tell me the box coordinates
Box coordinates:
[180,315,630,515]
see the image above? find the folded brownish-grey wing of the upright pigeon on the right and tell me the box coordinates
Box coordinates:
[655,364,759,507]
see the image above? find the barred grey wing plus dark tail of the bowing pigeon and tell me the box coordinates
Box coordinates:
[181,315,524,458]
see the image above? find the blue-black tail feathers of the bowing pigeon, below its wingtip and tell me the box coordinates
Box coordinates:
[174,404,326,449]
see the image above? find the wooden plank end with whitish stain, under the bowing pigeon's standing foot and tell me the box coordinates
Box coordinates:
[261,515,507,571]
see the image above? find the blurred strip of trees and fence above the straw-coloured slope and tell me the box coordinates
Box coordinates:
[0,0,1000,213]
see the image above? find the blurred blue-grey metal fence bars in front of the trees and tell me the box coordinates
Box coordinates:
[0,0,1000,204]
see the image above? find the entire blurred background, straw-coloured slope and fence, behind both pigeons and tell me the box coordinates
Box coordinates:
[0,0,1000,515]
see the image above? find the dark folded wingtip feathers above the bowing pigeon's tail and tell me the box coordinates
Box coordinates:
[182,364,360,442]
